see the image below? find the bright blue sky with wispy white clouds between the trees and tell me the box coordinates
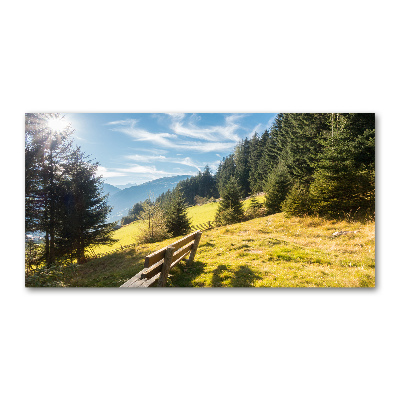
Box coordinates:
[65,113,276,185]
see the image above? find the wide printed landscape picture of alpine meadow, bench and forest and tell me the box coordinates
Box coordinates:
[25,113,375,290]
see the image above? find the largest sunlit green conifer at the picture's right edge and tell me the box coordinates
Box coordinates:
[310,114,375,218]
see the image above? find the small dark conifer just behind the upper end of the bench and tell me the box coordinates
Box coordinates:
[165,187,190,236]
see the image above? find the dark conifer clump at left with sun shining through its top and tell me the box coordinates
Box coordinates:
[25,114,114,266]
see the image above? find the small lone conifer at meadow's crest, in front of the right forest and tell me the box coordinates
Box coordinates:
[215,177,244,225]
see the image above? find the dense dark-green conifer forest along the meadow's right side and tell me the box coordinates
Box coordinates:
[216,113,375,218]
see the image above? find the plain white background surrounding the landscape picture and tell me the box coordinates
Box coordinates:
[0,0,400,400]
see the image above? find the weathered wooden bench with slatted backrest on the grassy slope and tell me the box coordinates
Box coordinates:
[120,231,201,287]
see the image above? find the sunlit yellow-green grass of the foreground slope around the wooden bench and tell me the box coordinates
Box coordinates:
[65,212,375,287]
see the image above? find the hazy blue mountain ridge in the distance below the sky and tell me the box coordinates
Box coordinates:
[108,175,190,221]
